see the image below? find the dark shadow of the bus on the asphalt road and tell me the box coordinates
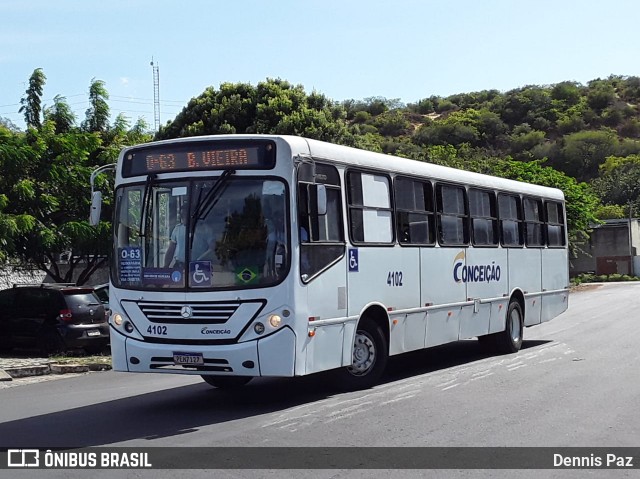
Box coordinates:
[0,341,549,449]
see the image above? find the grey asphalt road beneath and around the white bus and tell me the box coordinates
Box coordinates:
[0,283,640,478]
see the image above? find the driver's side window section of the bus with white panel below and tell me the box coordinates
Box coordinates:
[294,168,354,374]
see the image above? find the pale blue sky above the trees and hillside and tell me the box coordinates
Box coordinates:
[0,0,640,128]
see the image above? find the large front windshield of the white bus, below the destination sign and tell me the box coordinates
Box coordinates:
[112,174,290,290]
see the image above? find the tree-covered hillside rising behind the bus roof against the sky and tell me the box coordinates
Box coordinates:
[156,76,640,215]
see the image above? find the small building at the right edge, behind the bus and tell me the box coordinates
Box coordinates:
[570,218,640,276]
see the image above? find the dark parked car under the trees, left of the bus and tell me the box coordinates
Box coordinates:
[0,283,109,354]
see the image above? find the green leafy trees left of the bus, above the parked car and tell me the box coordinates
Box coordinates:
[0,69,151,284]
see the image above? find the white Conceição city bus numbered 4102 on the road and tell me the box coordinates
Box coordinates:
[94,135,569,388]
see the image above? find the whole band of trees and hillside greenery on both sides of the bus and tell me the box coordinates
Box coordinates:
[0,69,640,284]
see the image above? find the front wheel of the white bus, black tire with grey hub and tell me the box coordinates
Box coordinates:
[339,320,389,390]
